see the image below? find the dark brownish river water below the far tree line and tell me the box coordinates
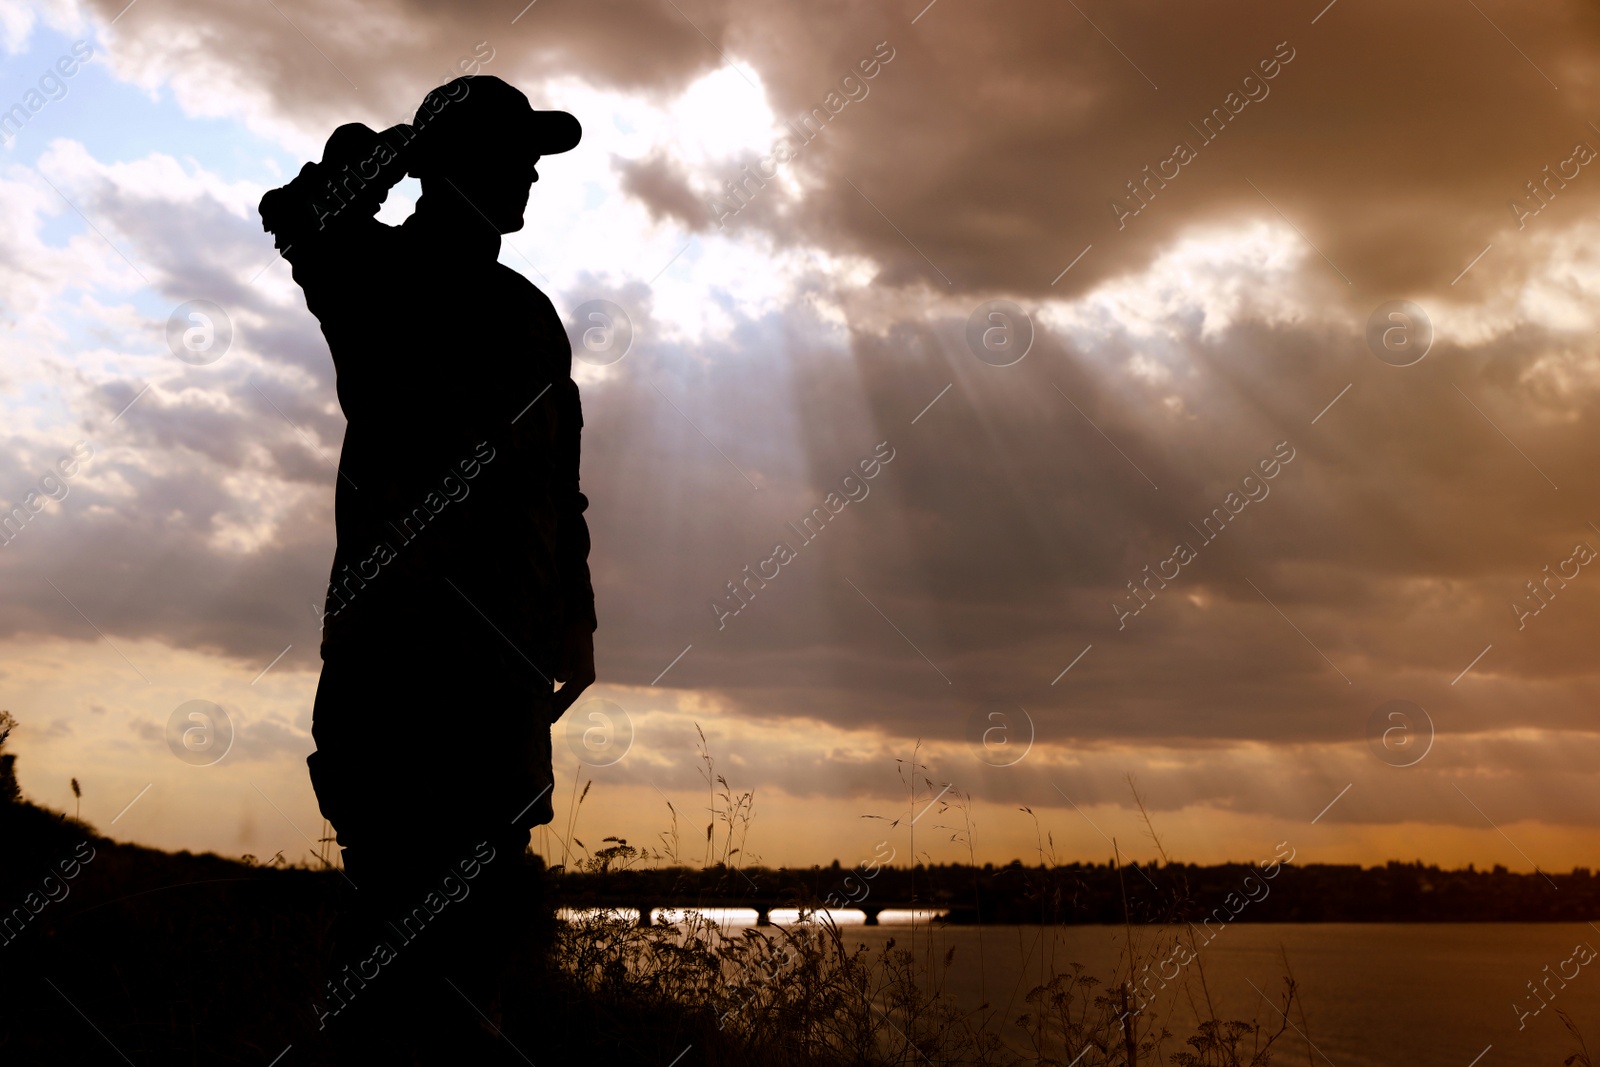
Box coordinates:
[624,912,1600,1067]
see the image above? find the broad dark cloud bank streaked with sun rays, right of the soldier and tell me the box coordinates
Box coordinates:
[556,255,1600,767]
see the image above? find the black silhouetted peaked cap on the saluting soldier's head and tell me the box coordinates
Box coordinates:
[408,74,584,176]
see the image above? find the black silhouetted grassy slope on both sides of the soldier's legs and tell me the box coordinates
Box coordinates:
[0,801,684,1067]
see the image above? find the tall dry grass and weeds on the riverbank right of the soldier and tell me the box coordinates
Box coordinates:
[549,733,1309,1067]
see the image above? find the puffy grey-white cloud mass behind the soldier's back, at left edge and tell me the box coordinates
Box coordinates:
[0,155,344,665]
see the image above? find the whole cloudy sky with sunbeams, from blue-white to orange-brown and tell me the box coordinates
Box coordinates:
[0,0,1600,870]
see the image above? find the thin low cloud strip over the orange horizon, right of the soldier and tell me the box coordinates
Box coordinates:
[611,716,1600,837]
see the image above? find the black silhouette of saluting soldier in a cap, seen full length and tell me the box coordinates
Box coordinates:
[261,75,595,1062]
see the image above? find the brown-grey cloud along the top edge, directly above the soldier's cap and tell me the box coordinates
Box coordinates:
[90,0,738,141]
